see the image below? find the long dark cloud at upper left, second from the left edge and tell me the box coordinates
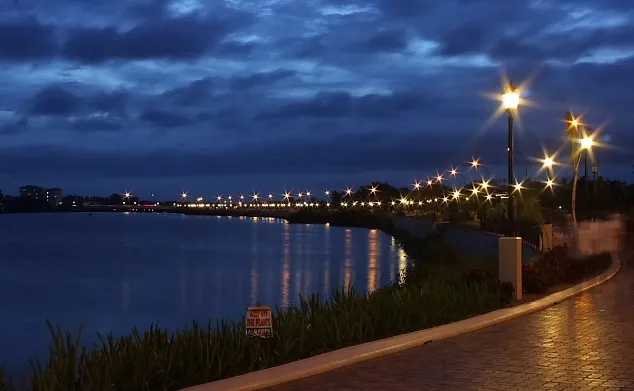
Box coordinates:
[62,14,251,63]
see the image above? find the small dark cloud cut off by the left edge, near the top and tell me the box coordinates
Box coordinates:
[0,17,57,61]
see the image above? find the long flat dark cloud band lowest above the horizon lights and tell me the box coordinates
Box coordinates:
[0,130,634,178]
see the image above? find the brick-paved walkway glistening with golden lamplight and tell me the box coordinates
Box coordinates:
[267,249,634,391]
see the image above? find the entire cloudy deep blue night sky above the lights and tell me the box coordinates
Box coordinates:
[0,0,634,199]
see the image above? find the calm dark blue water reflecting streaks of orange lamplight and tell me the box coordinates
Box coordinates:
[0,213,407,371]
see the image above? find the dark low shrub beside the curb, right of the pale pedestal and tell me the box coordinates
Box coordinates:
[522,245,612,293]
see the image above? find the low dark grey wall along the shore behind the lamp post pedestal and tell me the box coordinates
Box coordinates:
[392,216,539,263]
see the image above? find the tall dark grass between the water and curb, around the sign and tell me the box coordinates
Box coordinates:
[0,265,502,391]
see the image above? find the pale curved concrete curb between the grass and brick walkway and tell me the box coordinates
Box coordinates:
[181,254,621,391]
